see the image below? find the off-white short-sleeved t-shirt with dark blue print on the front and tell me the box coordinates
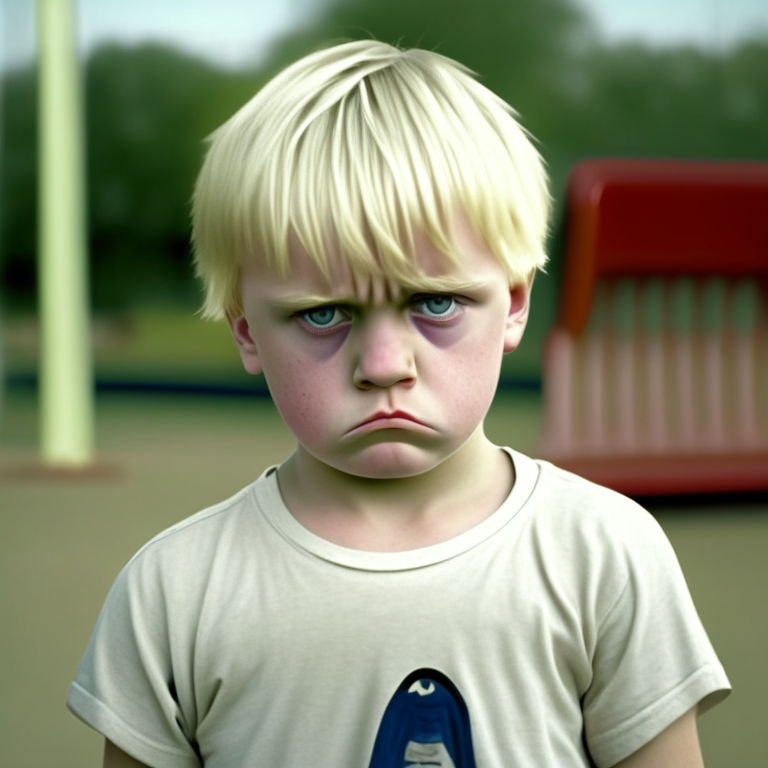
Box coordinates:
[67,451,730,768]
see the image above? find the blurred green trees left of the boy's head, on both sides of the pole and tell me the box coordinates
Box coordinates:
[0,45,263,309]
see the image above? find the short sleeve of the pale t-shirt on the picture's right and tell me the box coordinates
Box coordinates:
[583,508,730,766]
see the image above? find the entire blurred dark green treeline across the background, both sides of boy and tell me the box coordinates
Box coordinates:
[0,0,768,312]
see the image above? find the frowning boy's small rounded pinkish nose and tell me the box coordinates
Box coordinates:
[354,315,416,389]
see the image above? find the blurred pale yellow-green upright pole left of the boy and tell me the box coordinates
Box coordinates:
[37,0,94,468]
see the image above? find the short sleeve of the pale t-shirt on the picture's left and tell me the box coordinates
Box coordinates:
[67,554,201,768]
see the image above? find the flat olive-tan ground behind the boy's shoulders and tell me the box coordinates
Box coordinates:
[0,389,768,768]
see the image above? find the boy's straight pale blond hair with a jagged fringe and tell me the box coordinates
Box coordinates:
[192,41,550,318]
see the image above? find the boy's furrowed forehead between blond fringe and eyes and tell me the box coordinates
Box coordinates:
[243,216,507,306]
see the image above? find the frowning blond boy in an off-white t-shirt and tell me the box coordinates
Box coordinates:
[68,42,729,768]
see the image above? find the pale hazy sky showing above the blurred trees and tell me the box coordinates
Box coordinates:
[0,0,768,71]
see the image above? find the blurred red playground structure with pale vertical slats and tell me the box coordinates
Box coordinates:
[540,159,768,496]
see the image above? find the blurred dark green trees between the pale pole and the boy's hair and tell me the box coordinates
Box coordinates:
[86,45,268,306]
